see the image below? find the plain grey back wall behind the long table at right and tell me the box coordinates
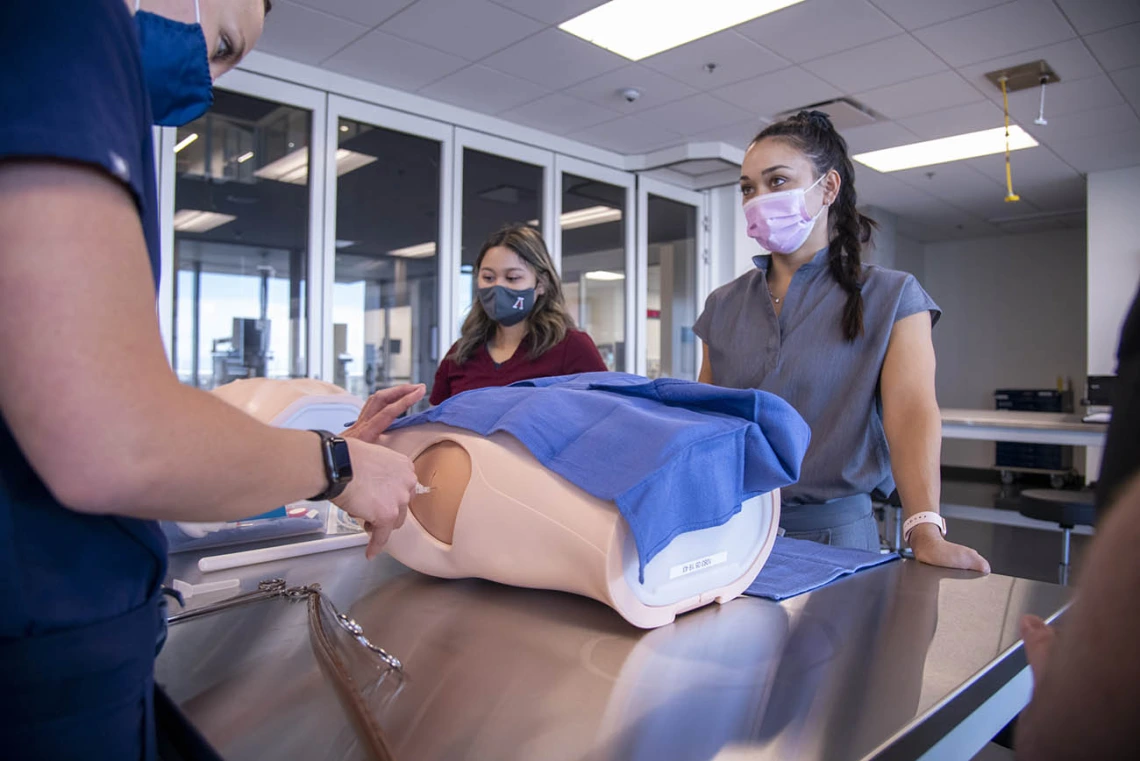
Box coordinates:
[920,230,1086,468]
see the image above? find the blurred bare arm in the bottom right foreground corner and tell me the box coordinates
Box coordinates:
[1016,481,1140,761]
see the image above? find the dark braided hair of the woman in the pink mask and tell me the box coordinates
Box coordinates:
[752,111,878,341]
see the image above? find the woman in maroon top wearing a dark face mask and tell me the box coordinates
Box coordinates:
[431,224,606,404]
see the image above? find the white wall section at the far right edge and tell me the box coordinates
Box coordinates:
[1088,166,1140,375]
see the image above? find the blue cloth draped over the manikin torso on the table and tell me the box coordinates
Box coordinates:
[392,373,811,578]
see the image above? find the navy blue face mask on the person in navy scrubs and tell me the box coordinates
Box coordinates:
[135,0,213,126]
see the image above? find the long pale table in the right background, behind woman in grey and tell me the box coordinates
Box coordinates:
[942,409,1108,447]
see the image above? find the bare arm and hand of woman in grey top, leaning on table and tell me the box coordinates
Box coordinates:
[880,311,990,573]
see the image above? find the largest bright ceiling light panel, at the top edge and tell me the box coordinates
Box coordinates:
[559,0,803,60]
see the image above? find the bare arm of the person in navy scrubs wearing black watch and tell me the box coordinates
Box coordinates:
[0,162,414,537]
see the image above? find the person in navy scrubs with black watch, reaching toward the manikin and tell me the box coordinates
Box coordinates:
[0,0,424,761]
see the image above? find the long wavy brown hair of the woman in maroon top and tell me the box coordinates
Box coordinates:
[448,224,573,365]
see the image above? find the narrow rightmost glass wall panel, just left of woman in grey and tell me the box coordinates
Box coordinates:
[646,194,698,381]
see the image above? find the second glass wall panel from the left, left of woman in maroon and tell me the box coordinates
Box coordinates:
[333,118,446,396]
